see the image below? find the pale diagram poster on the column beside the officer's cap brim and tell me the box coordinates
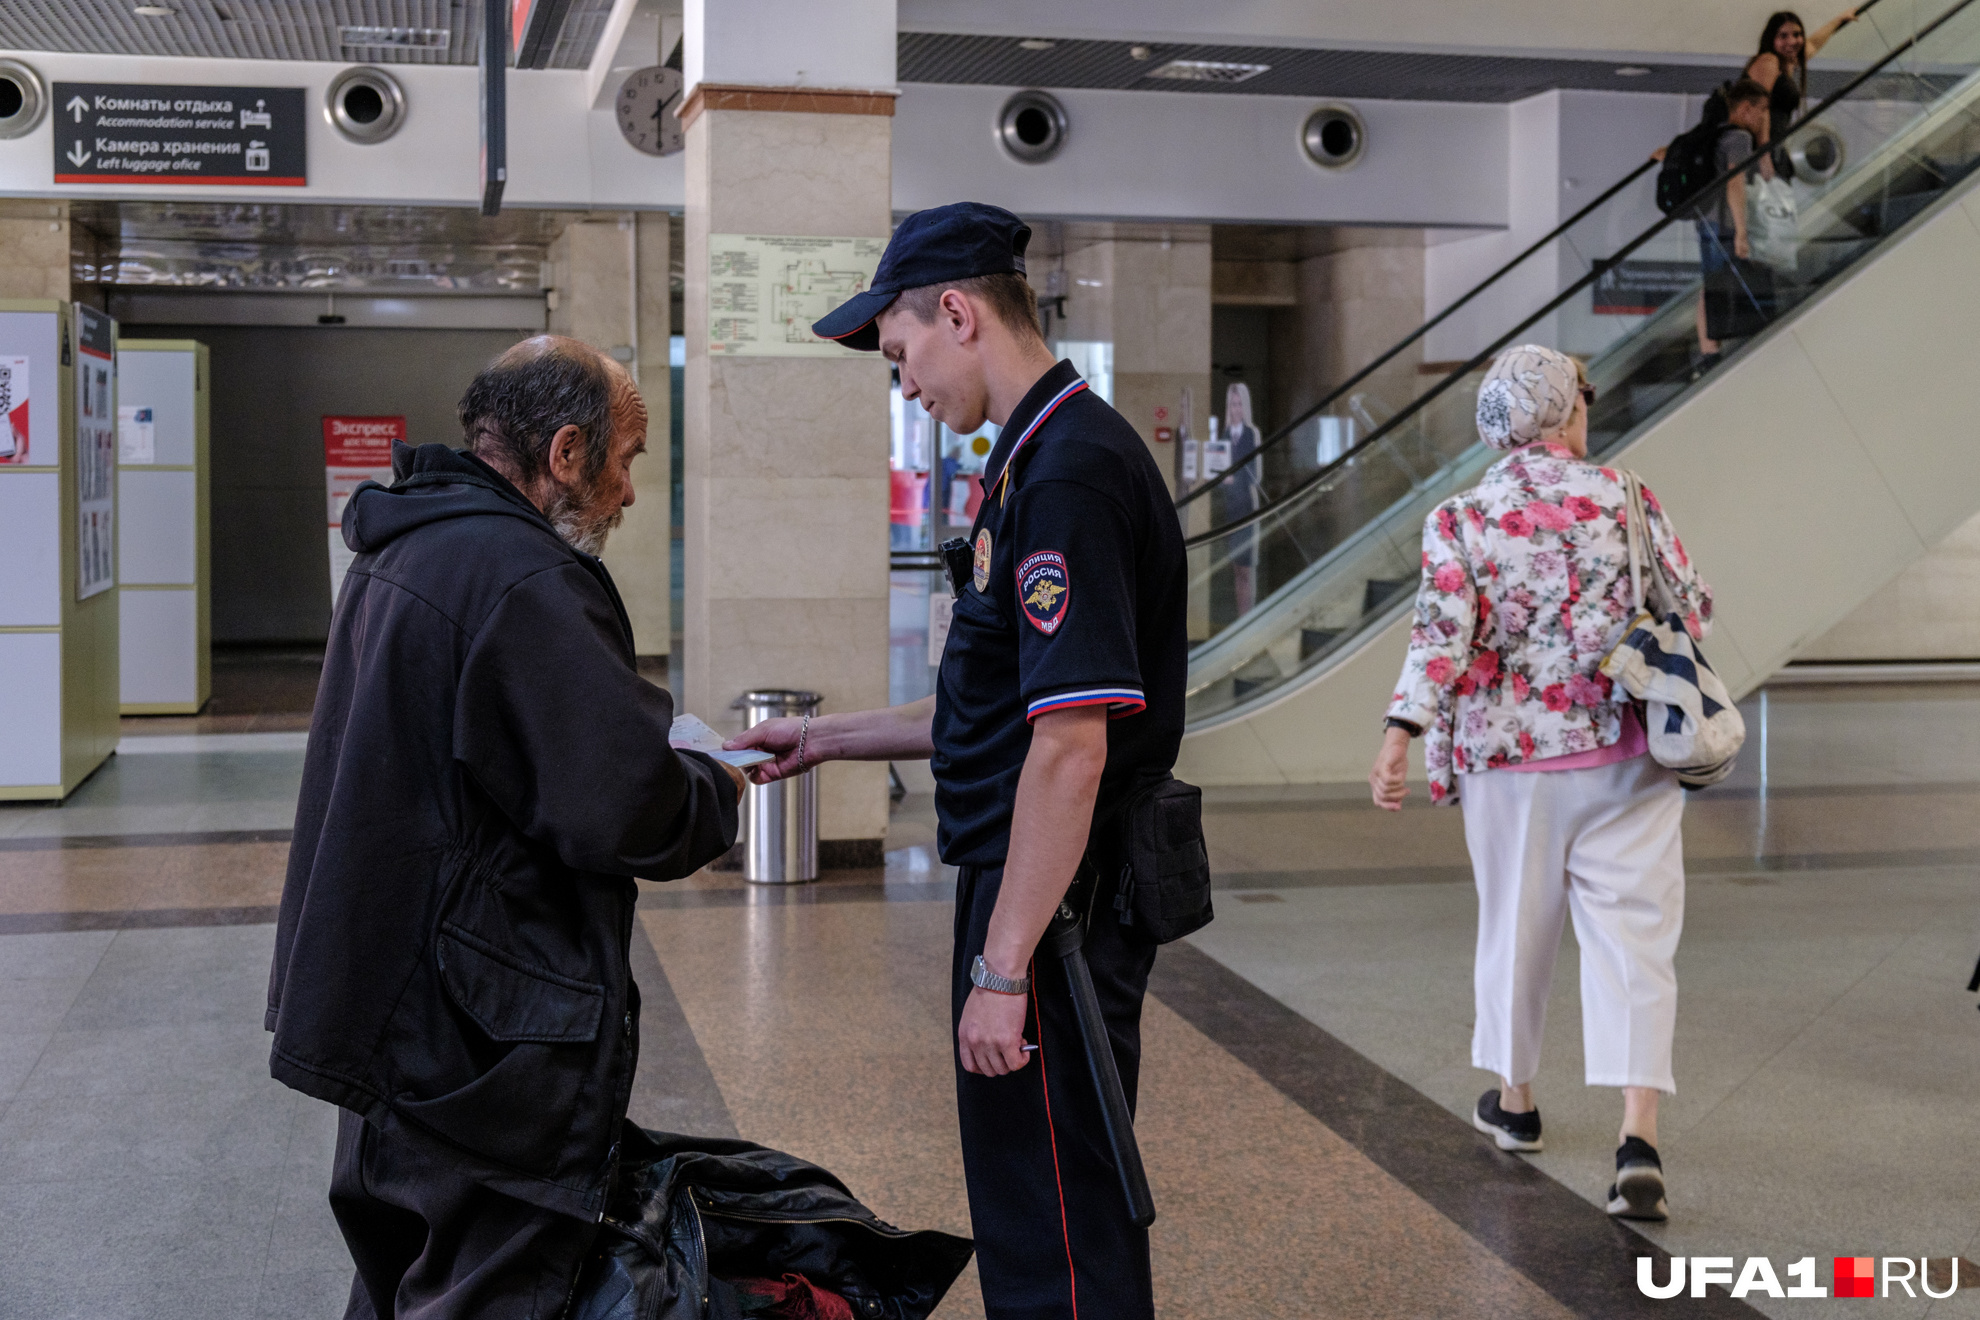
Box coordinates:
[709,234,887,358]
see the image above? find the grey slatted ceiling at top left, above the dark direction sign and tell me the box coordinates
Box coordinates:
[0,0,612,69]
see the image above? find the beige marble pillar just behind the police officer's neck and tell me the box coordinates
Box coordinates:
[1061,226,1222,494]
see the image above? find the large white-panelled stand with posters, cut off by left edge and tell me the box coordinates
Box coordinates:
[0,301,119,800]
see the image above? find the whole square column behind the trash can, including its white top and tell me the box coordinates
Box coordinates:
[681,0,897,867]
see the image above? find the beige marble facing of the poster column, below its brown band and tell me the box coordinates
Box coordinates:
[681,109,893,839]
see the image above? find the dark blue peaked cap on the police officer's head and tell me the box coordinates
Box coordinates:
[812,202,1032,352]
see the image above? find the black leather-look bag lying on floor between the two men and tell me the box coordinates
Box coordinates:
[566,1122,976,1320]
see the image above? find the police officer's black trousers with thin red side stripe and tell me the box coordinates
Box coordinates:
[950,867,1154,1320]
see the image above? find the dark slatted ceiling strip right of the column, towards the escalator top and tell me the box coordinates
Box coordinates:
[901,32,1738,103]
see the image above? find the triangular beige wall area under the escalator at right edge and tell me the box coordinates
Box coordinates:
[1794,519,1980,661]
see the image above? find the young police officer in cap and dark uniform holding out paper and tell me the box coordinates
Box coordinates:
[731,202,1188,1320]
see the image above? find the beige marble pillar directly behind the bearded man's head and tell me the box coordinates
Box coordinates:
[550,212,673,655]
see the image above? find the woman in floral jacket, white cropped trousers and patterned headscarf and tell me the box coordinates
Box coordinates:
[1370,344,1713,1219]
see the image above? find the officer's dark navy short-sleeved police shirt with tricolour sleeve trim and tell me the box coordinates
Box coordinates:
[933,362,1188,867]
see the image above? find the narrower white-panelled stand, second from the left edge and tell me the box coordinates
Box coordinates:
[117,338,214,714]
